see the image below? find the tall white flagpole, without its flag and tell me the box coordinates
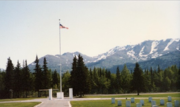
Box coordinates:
[59,19,62,92]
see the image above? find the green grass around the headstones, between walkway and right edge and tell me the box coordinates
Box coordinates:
[71,98,179,107]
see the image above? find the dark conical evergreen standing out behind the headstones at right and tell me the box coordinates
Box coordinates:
[132,63,145,95]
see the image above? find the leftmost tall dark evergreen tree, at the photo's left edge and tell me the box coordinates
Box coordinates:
[5,58,14,97]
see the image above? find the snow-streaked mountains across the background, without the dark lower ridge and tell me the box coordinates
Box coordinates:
[29,38,180,71]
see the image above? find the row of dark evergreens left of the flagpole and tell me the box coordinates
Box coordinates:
[0,56,59,98]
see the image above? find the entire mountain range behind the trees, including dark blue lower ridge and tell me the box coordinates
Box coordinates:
[28,38,180,73]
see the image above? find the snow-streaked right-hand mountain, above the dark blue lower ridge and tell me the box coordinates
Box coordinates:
[88,38,180,68]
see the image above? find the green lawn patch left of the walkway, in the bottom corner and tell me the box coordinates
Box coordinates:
[0,102,40,107]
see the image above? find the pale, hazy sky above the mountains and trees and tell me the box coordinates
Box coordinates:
[0,1,180,69]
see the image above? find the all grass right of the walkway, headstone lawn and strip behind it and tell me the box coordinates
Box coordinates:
[71,93,180,107]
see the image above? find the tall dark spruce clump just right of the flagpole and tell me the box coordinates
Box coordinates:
[71,54,91,97]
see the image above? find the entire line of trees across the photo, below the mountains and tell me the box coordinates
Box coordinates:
[0,55,180,98]
